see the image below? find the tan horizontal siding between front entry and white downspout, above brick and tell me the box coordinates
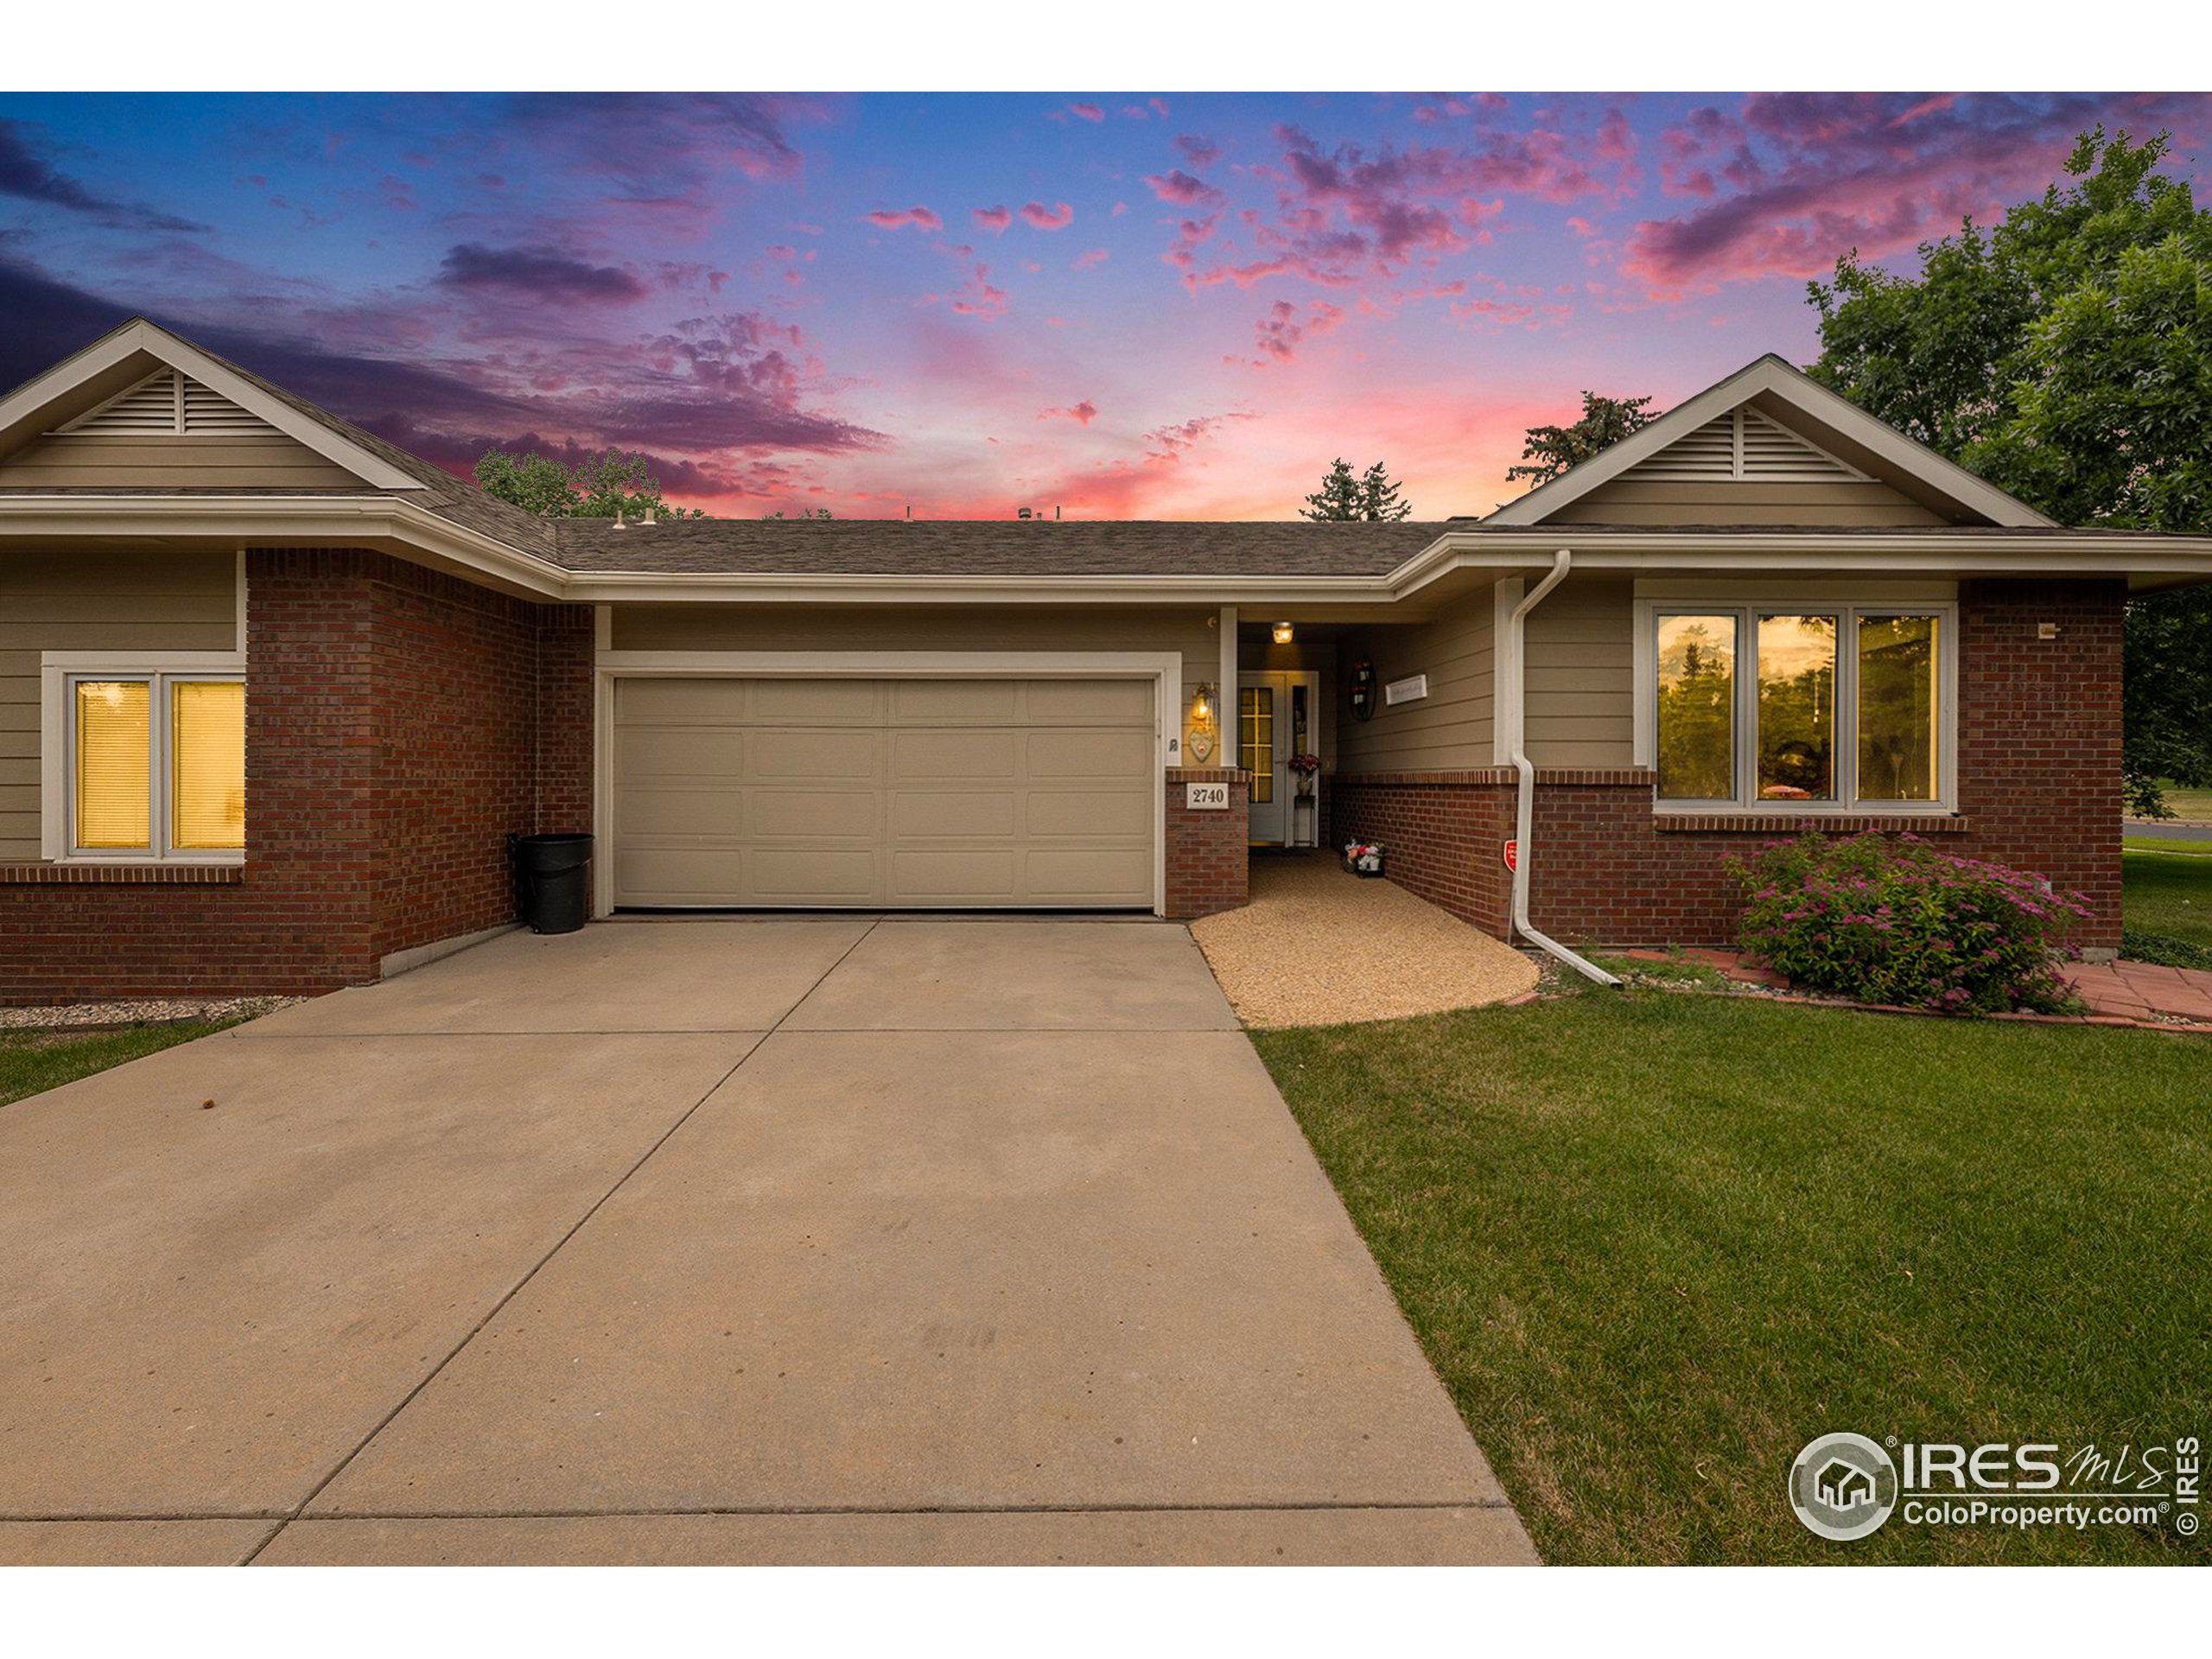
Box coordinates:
[1336,588,1496,772]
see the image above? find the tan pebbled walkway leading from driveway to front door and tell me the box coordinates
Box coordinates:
[1190,852,1535,1027]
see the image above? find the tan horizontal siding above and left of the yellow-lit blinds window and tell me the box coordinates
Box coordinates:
[0,549,238,862]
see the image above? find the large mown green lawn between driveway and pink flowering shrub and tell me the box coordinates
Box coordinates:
[1255,991,2212,1561]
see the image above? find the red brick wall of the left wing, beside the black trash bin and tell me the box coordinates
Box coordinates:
[0,549,591,1004]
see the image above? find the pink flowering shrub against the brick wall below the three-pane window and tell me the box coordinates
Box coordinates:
[1734,834,2088,1013]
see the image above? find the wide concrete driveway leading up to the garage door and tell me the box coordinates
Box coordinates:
[0,918,1533,1564]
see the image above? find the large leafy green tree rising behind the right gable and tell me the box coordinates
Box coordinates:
[1809,128,2212,817]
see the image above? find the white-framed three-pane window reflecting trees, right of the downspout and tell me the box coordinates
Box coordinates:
[1635,593,1958,814]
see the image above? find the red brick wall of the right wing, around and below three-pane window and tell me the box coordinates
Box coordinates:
[1332,582,2126,947]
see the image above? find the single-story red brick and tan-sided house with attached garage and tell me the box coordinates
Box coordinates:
[0,321,2212,1002]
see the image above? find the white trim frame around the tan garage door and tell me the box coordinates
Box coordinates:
[591,650,1185,918]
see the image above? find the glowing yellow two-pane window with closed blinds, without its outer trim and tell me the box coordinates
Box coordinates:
[67,672,245,861]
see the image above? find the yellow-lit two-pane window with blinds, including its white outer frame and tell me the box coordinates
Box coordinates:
[40,651,245,865]
